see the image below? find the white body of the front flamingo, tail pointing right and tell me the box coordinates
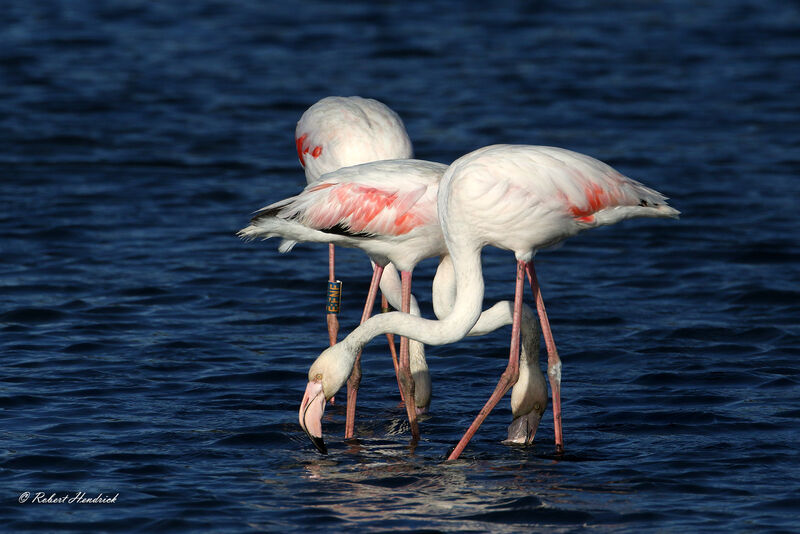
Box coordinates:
[439,145,678,260]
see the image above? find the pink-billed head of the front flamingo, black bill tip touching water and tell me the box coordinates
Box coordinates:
[299,343,355,454]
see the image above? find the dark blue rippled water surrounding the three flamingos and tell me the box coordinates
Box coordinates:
[0,0,800,533]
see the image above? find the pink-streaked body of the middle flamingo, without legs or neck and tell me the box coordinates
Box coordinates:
[239,160,447,271]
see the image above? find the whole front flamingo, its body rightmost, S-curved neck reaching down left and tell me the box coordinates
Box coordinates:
[300,145,679,459]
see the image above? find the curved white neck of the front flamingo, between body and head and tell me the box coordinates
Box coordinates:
[340,243,483,351]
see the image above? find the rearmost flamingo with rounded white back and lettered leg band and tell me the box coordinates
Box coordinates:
[295,96,414,348]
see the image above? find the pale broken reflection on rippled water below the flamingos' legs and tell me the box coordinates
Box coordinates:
[292,441,588,532]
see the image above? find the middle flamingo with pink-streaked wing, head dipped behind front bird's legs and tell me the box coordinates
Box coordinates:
[239,160,547,451]
